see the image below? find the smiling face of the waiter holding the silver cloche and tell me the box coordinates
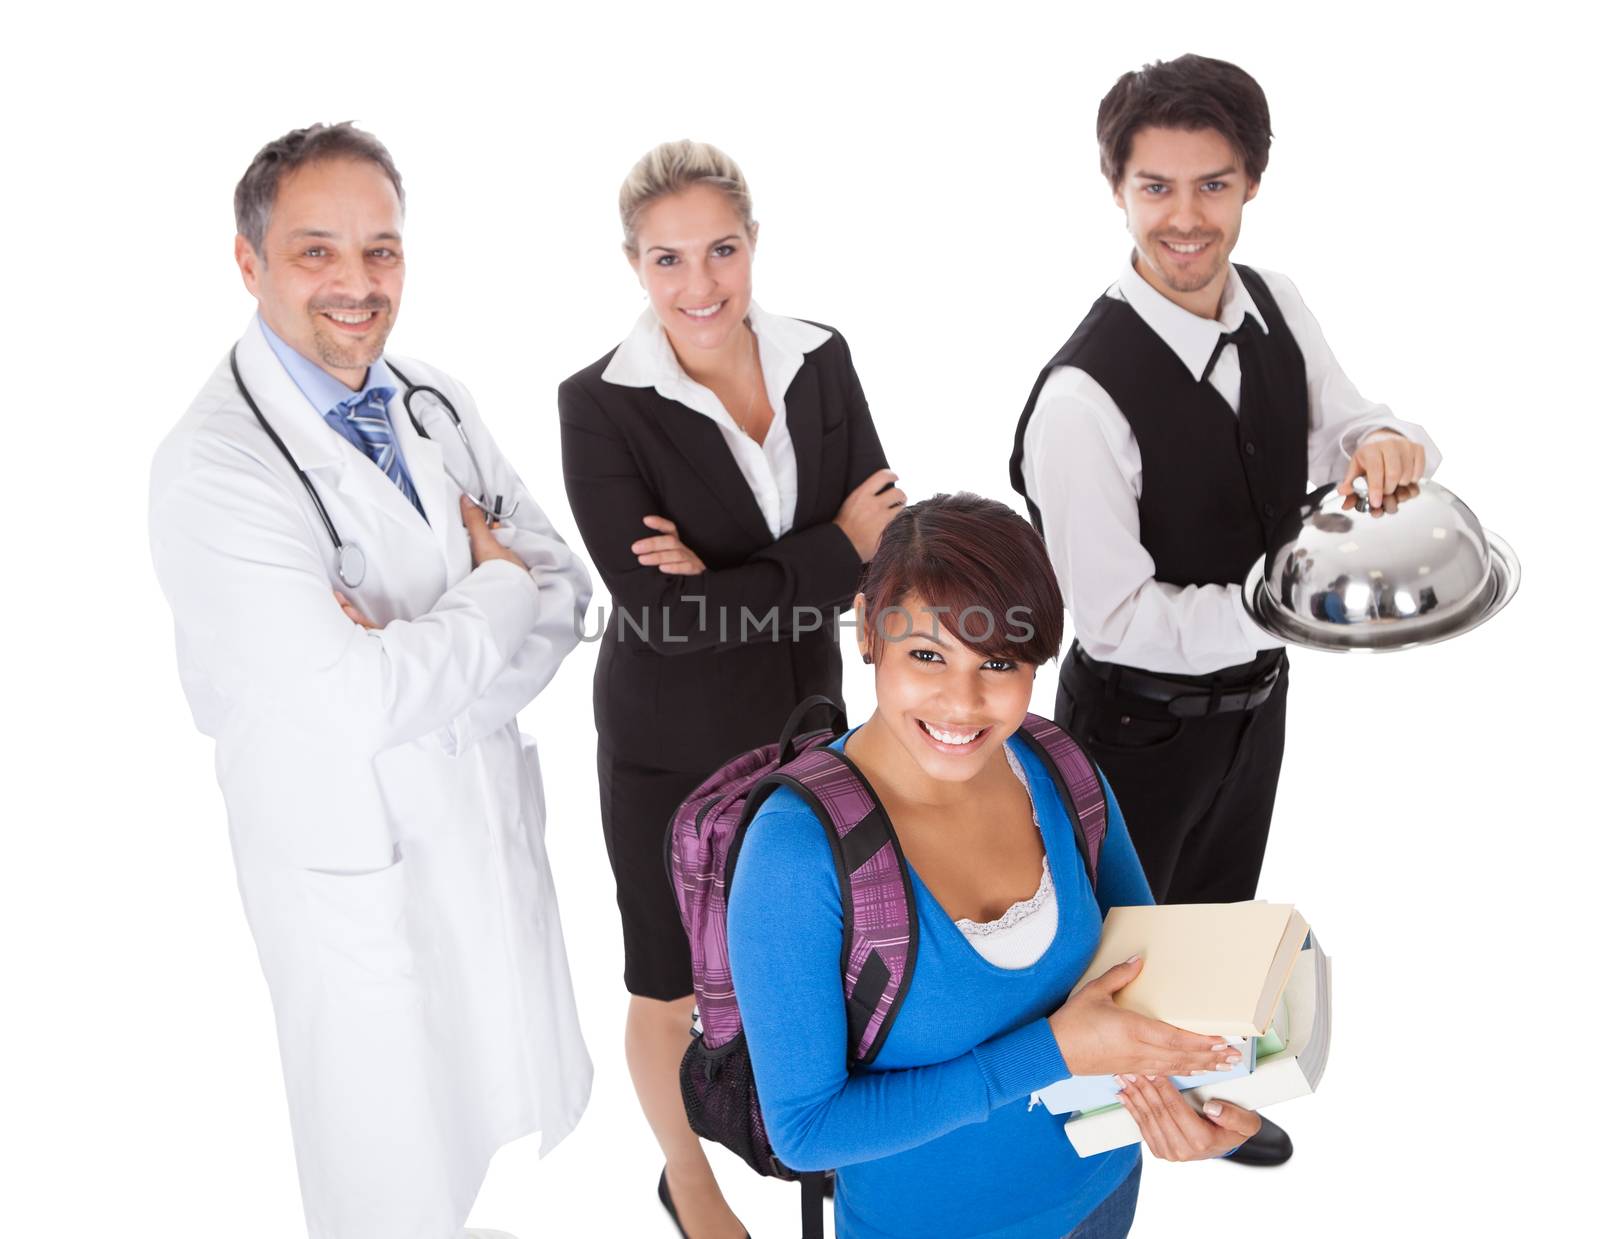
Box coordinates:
[1115,128,1258,319]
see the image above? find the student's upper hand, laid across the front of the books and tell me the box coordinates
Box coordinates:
[1050,956,1238,1082]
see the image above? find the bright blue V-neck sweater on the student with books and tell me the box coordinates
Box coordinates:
[728,738,1152,1239]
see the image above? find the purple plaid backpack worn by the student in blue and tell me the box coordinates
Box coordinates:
[667,696,1106,1236]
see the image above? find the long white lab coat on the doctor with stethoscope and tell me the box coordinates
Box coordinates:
[150,323,592,1239]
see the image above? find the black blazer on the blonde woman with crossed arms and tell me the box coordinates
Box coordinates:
[558,328,885,773]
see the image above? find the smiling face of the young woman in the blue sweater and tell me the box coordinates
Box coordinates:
[856,594,1035,783]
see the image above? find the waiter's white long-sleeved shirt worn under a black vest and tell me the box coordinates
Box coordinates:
[1022,256,1438,676]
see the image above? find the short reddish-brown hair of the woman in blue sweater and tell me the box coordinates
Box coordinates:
[861,491,1064,666]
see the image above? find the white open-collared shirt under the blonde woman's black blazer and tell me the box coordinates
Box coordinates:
[600,301,832,541]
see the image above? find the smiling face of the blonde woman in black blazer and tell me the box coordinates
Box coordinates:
[629,184,755,359]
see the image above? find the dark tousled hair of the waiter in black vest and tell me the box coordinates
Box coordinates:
[1094,54,1272,189]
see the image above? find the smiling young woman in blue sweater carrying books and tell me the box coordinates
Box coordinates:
[726,495,1259,1239]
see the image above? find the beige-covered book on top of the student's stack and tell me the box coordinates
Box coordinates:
[1072,901,1307,1037]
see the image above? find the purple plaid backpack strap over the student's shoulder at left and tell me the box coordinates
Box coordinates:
[768,746,917,1068]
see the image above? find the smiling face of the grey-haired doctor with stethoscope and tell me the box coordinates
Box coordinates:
[234,158,405,391]
